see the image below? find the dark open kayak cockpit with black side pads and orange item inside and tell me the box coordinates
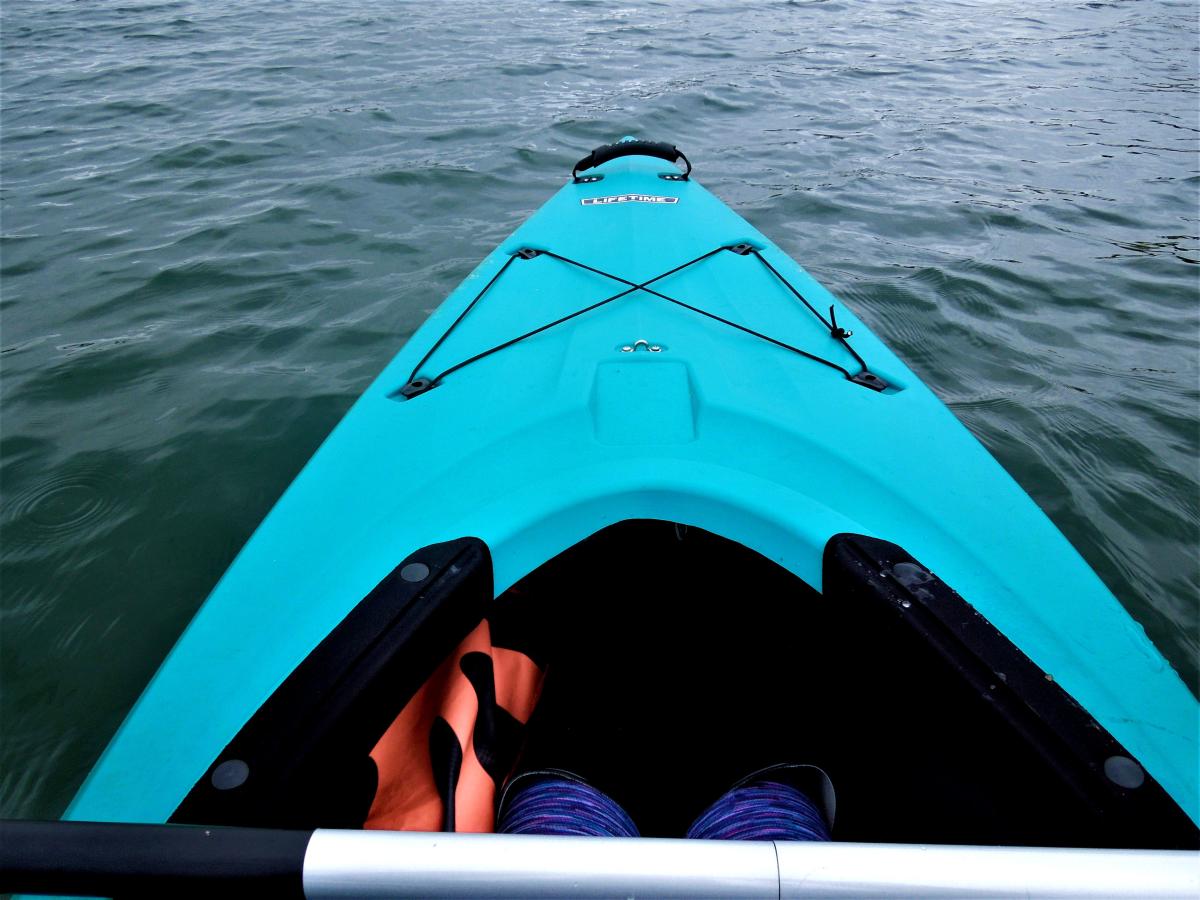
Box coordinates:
[172,521,1196,847]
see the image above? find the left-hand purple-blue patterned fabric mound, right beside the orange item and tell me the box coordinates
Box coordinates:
[496,775,640,838]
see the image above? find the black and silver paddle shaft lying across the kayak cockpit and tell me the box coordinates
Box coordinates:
[0,822,1200,900]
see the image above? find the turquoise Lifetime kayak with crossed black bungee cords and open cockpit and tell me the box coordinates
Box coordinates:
[67,140,1200,847]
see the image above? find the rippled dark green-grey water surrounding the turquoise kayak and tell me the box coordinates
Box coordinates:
[0,0,1200,816]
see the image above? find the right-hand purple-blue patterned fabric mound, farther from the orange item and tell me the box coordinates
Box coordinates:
[688,781,829,841]
